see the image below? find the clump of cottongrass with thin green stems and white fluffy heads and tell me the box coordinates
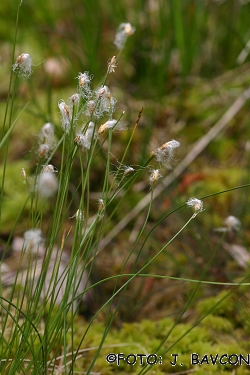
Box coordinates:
[0,1,248,375]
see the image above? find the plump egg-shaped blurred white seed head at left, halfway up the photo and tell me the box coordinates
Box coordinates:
[37,171,58,198]
